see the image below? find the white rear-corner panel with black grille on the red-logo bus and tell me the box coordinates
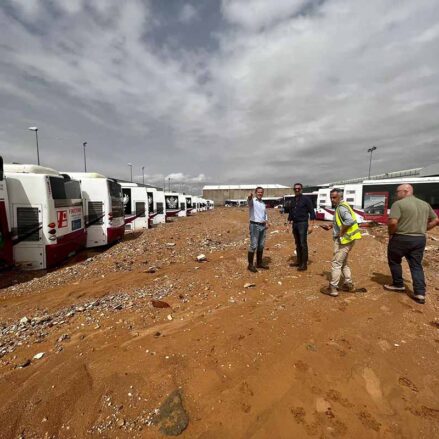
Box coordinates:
[12,204,46,270]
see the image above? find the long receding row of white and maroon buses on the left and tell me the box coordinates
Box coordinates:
[0,157,214,270]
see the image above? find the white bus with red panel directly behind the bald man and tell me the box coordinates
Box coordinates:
[362,177,439,223]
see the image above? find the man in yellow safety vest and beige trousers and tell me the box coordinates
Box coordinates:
[320,189,361,297]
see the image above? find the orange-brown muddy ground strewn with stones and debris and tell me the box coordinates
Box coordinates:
[0,208,439,439]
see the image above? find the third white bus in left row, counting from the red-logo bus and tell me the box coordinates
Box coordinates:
[119,181,149,232]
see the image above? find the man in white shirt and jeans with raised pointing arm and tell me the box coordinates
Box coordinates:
[247,186,268,273]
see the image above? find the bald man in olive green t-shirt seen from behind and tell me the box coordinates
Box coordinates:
[384,184,439,303]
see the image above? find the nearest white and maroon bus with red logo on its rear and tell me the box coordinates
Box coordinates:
[4,164,87,270]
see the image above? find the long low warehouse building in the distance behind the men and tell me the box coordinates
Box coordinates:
[203,184,293,206]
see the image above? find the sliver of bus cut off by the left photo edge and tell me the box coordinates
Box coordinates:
[0,157,14,267]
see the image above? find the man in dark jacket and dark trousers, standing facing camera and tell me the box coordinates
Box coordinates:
[288,183,316,271]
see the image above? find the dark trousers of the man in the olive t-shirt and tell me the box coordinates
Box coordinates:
[387,235,426,295]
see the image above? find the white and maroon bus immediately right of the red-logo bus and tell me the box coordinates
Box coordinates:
[67,172,125,247]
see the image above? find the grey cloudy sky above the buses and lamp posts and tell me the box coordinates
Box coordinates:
[0,0,439,192]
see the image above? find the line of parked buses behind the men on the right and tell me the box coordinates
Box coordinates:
[283,177,439,224]
